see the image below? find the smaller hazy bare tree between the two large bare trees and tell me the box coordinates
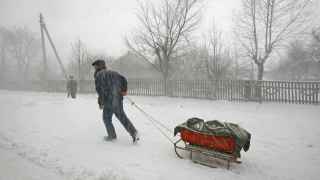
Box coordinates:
[170,25,248,80]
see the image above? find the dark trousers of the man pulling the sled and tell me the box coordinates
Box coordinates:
[103,97,137,138]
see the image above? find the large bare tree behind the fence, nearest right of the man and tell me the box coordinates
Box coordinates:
[126,0,201,91]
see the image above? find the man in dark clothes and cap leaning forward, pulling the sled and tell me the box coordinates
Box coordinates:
[92,60,139,143]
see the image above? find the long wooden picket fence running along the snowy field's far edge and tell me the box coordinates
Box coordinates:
[1,79,320,104]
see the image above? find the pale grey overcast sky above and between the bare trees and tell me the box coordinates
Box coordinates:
[0,0,318,58]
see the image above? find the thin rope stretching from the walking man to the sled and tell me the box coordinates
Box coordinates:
[126,97,174,144]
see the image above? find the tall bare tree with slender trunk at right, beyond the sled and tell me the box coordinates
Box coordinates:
[235,0,312,80]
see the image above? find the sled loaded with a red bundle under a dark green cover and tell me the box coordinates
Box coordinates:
[174,118,251,169]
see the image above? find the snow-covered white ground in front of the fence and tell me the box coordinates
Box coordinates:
[0,91,320,180]
